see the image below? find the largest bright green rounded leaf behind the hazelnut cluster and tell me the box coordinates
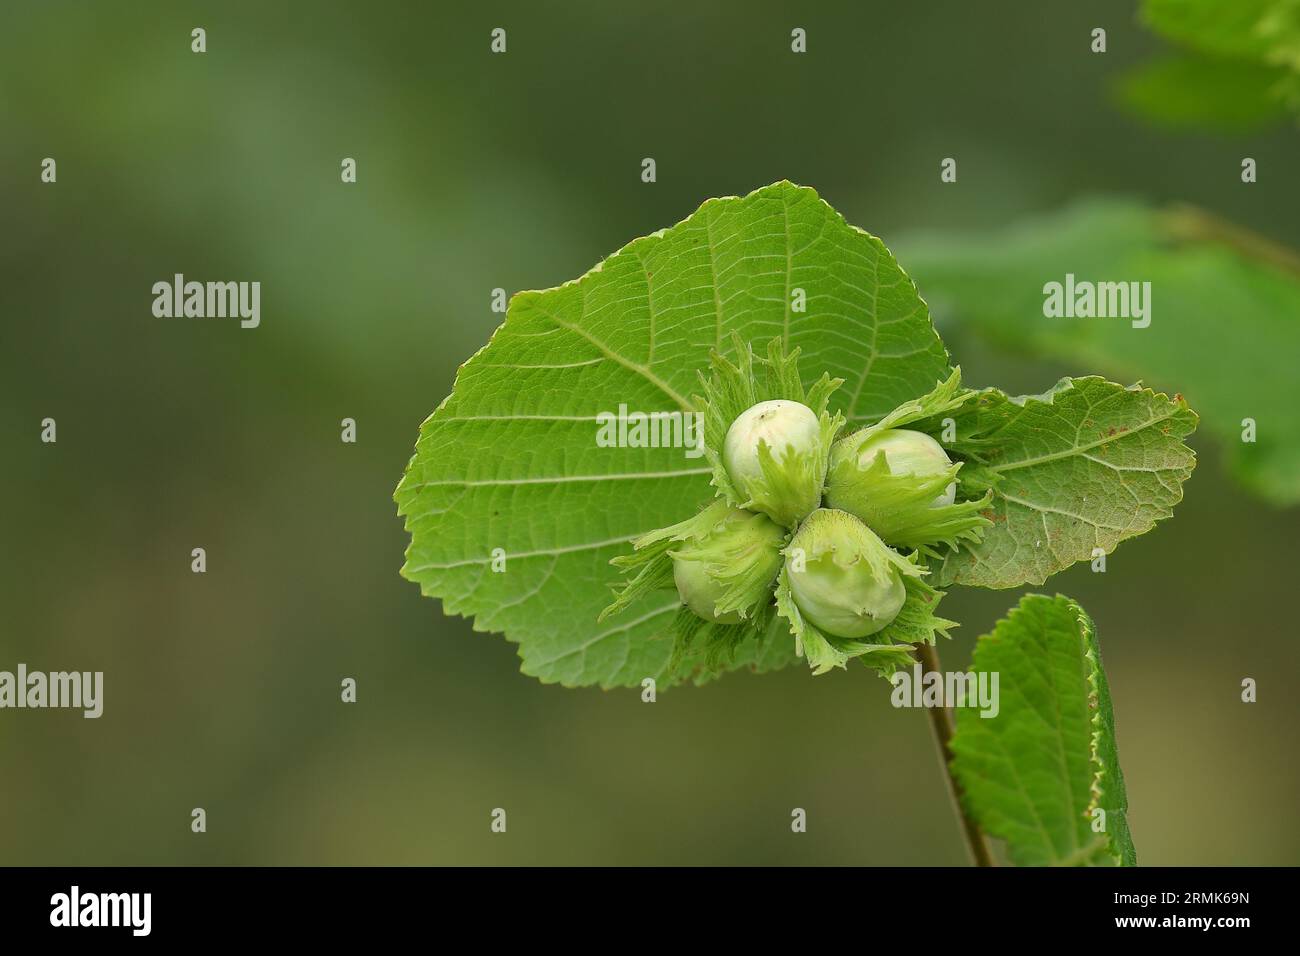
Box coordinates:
[395,182,949,687]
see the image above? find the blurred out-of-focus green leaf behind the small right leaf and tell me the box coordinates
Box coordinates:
[898,200,1300,505]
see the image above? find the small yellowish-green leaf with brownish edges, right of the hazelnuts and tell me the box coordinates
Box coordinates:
[939,376,1196,588]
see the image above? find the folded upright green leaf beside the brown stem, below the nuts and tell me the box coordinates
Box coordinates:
[952,594,1136,866]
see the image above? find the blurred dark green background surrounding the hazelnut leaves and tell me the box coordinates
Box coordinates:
[0,0,1300,864]
